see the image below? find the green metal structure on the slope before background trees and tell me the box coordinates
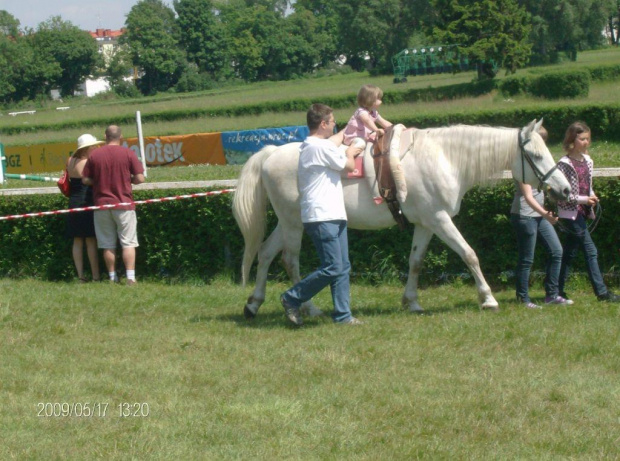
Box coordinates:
[392,45,496,83]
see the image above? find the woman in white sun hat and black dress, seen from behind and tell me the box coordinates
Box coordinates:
[65,134,103,283]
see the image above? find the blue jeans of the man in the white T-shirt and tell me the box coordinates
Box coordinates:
[284,220,351,322]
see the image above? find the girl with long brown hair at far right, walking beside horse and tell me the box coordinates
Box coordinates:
[558,122,620,303]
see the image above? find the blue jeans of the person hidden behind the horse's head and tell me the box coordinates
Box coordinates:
[510,214,562,303]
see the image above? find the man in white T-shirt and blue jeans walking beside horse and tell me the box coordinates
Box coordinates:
[280,104,362,326]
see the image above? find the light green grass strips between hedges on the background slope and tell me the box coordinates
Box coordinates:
[0,48,620,146]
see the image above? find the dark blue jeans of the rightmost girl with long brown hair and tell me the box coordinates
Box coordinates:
[560,214,607,296]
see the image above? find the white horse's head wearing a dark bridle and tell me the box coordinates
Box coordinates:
[512,119,570,200]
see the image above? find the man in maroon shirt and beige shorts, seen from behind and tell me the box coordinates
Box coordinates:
[82,125,144,285]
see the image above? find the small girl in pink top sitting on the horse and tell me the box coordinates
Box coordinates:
[343,85,392,147]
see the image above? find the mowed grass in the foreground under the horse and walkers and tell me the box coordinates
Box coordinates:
[0,279,620,460]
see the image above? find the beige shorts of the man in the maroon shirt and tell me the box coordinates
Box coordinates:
[95,210,138,250]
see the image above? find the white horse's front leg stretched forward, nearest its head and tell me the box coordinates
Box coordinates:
[435,212,499,311]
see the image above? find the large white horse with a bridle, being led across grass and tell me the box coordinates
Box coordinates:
[233,120,570,318]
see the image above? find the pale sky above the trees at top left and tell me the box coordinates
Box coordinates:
[0,0,172,31]
